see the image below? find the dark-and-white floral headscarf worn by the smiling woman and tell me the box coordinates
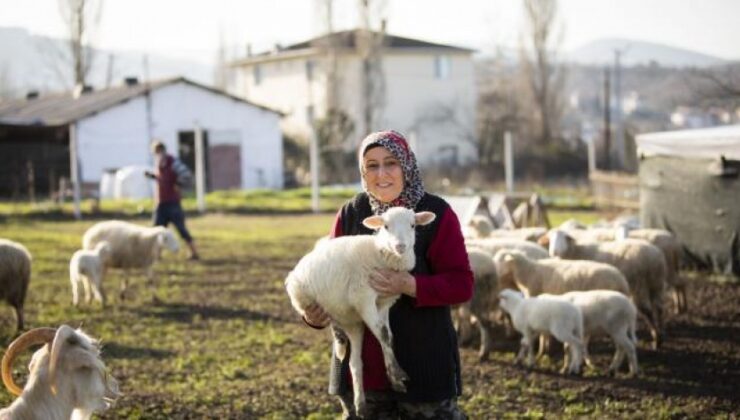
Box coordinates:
[358,130,424,214]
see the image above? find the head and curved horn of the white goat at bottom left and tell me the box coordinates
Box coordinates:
[2,325,119,411]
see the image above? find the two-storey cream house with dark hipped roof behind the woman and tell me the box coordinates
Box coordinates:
[231,30,476,166]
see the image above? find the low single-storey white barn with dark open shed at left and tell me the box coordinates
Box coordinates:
[0,78,283,198]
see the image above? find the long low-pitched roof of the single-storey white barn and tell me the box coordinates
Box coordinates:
[0,77,282,126]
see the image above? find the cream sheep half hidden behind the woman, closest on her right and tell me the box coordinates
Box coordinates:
[452,248,498,360]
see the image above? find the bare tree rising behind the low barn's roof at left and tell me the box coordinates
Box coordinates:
[59,0,102,86]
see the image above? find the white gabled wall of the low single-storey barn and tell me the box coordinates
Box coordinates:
[78,83,283,189]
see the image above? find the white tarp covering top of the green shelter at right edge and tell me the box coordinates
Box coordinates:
[635,125,740,160]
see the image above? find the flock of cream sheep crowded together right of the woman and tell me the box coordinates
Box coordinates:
[455,216,686,376]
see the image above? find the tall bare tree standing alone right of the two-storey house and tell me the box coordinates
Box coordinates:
[521,0,565,145]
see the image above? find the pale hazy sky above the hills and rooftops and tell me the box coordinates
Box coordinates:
[0,0,740,61]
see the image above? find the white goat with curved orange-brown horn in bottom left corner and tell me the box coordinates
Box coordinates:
[0,325,119,420]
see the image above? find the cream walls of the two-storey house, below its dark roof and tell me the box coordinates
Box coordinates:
[231,49,477,166]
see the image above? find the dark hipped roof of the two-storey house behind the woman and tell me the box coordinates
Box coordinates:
[231,29,475,63]
